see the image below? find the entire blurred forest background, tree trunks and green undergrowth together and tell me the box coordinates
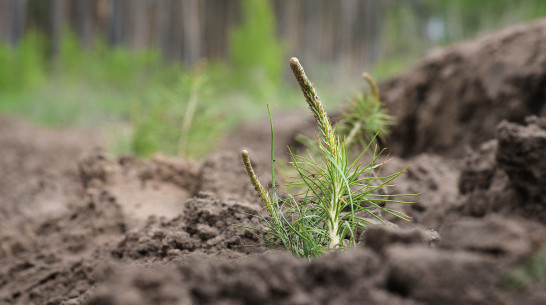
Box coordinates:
[0,0,546,158]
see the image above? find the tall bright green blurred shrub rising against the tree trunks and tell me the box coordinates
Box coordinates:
[230,0,284,97]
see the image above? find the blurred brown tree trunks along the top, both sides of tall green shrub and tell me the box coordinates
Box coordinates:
[0,0,396,71]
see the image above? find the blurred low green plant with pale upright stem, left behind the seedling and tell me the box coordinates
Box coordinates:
[131,65,226,158]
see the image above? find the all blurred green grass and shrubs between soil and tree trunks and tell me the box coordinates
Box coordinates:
[0,0,546,158]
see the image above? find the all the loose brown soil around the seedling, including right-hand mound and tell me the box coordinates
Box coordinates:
[0,20,546,305]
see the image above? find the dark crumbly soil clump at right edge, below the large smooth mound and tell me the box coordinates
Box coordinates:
[459,117,546,223]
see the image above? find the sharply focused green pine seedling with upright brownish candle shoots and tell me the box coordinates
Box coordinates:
[242,58,412,258]
